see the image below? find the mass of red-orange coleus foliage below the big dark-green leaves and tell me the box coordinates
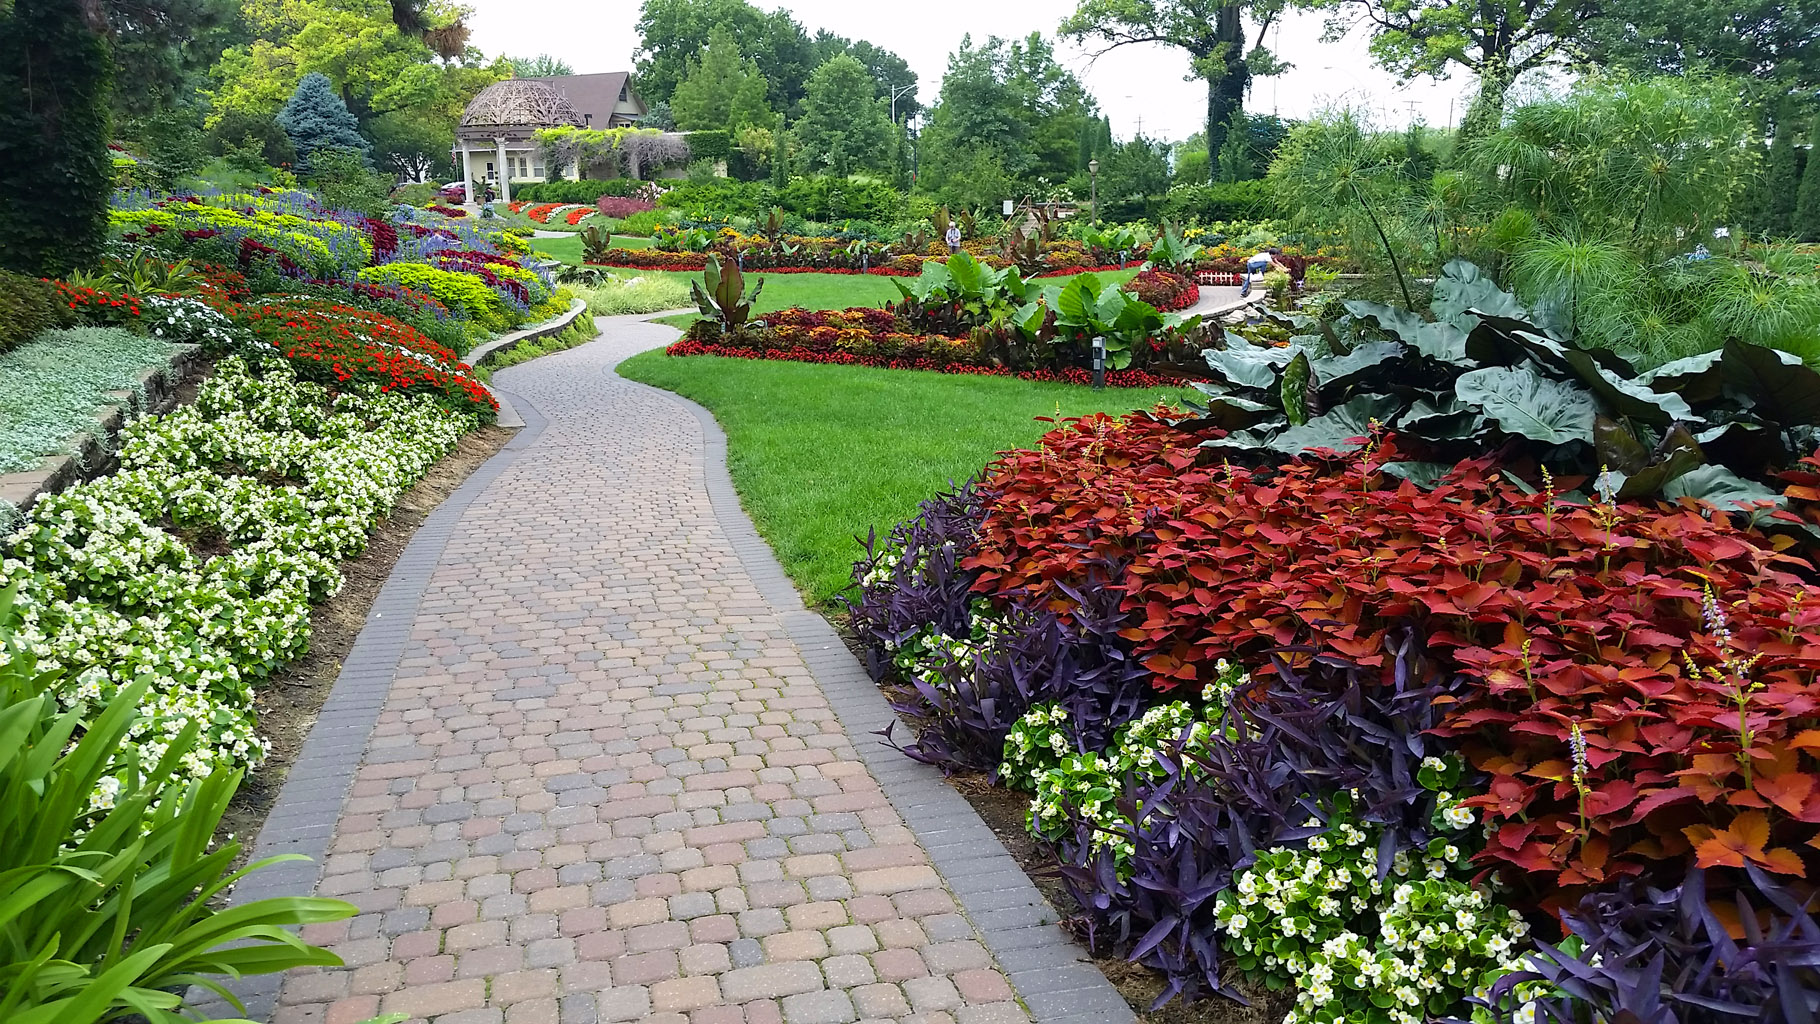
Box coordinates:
[968,417,1820,886]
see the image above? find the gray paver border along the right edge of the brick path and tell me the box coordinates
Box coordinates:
[608,331,1138,1024]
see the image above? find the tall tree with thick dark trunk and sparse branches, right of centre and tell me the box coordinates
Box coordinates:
[1061,0,1287,180]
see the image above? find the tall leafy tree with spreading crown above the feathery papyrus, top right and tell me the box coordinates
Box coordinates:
[1298,0,1602,138]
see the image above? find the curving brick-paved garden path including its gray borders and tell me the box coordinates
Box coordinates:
[238,318,1132,1024]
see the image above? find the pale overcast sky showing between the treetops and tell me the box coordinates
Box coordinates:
[468,0,1472,140]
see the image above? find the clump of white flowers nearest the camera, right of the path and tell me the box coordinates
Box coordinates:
[1216,815,1529,1024]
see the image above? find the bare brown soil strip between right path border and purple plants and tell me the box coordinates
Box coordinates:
[821,607,1294,1024]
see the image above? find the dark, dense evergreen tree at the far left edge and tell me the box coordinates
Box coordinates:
[0,0,113,276]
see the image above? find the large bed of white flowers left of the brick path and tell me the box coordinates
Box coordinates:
[0,358,473,808]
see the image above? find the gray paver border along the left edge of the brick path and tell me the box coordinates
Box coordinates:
[195,387,546,1020]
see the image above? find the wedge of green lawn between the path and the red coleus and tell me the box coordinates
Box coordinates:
[619,349,1179,606]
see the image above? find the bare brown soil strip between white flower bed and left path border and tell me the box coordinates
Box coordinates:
[217,426,517,858]
